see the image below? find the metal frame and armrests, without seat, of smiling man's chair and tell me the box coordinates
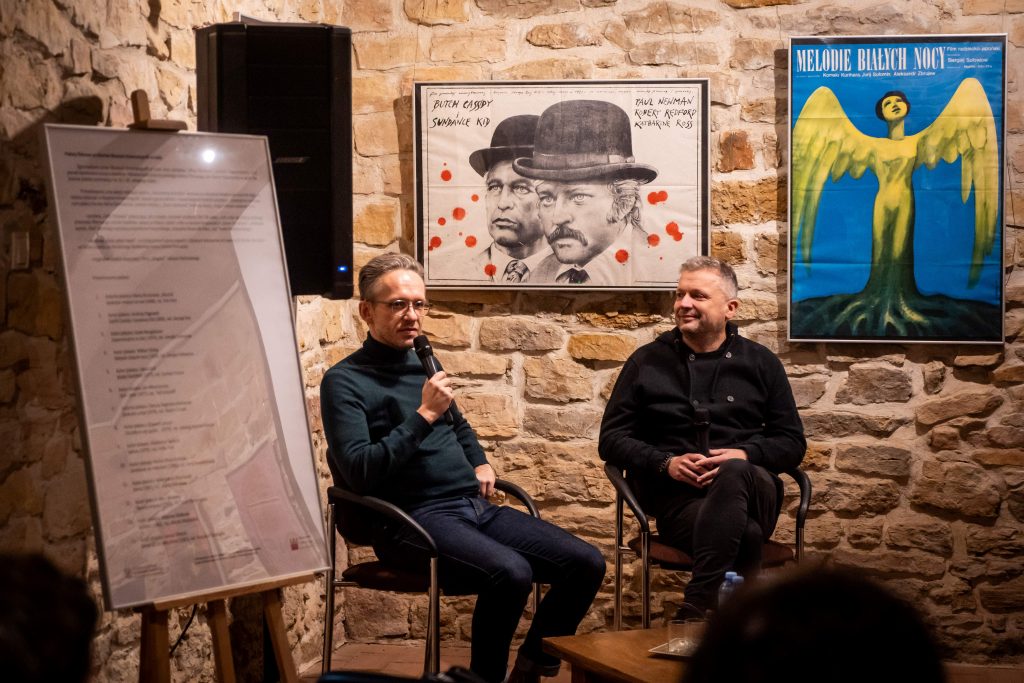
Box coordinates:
[604,464,811,631]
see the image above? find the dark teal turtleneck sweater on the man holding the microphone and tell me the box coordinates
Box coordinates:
[321,335,487,508]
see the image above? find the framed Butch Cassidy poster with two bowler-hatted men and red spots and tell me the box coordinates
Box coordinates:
[415,79,709,290]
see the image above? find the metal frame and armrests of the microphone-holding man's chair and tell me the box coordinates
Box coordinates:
[321,479,541,677]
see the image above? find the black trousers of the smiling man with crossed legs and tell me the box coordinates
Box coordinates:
[655,460,780,610]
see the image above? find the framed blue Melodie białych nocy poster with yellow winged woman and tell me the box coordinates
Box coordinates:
[790,35,1006,342]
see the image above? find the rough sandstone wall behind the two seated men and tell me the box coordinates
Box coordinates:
[0,0,1024,681]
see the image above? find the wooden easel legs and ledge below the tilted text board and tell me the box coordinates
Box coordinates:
[138,574,315,683]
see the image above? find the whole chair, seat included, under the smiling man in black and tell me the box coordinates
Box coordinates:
[604,464,811,631]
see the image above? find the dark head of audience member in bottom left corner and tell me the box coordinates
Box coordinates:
[0,554,97,683]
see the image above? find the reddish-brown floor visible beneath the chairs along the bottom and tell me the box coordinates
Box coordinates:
[300,641,1024,683]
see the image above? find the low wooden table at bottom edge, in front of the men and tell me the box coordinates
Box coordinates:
[544,627,686,683]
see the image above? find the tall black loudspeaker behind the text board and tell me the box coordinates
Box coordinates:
[196,23,352,299]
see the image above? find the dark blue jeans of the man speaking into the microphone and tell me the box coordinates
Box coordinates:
[374,497,605,683]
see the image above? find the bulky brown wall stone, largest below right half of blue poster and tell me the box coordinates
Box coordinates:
[909,462,1001,519]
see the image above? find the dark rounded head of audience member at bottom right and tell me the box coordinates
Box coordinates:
[683,567,945,683]
